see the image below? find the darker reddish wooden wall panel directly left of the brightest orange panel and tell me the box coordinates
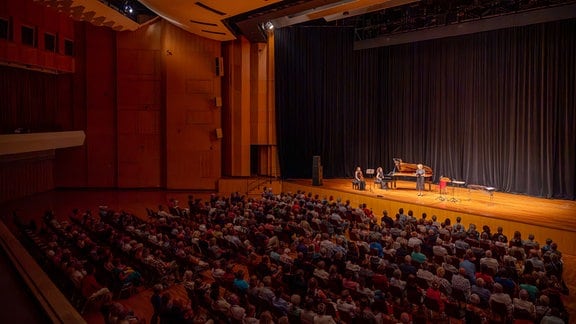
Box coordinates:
[116,23,164,188]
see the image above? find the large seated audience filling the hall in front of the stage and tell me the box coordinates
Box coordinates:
[18,189,568,323]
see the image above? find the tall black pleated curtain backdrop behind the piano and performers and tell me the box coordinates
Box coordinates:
[274,19,576,200]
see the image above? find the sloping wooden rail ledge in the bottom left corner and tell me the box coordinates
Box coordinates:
[0,221,86,324]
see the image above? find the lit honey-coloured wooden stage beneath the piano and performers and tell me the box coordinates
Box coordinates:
[282,179,576,255]
